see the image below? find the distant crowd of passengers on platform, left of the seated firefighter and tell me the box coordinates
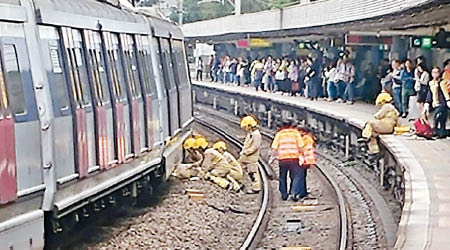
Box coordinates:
[209,56,355,104]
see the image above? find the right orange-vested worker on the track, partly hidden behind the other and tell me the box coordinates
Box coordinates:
[298,126,316,198]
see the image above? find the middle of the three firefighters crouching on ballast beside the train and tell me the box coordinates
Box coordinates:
[202,141,233,189]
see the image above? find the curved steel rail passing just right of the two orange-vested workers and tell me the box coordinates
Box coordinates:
[196,110,349,250]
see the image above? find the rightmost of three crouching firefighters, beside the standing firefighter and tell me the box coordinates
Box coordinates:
[213,141,244,192]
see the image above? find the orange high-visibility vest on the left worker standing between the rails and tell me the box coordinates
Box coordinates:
[272,128,303,160]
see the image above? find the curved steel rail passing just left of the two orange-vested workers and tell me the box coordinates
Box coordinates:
[195,118,272,249]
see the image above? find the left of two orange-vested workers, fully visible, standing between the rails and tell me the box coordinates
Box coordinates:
[272,121,304,201]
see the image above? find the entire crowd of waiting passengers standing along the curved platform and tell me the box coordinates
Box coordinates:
[201,53,450,137]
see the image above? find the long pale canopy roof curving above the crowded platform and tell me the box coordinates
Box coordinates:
[182,0,450,42]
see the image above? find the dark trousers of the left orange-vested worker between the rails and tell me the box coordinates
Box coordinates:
[278,160,307,197]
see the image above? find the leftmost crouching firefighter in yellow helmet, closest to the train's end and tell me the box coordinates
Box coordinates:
[173,137,203,178]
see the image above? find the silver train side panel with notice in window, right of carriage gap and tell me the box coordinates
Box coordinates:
[39,26,76,182]
